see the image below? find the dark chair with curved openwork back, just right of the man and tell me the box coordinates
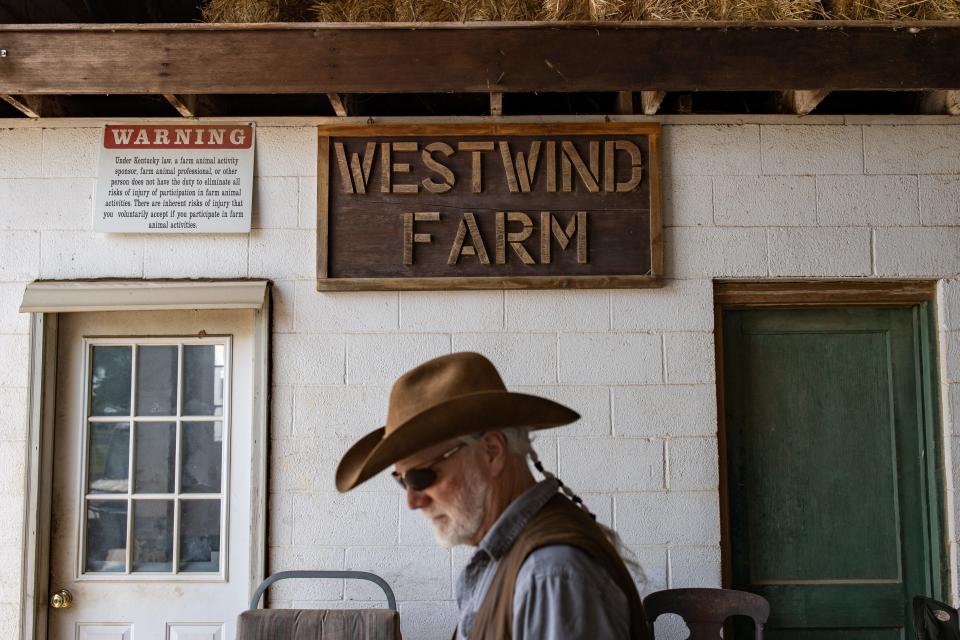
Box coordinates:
[643,589,770,640]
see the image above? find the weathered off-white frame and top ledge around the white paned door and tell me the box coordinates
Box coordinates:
[20,280,272,640]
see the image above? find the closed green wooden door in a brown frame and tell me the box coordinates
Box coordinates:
[723,307,942,640]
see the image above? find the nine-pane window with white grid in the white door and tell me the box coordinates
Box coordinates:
[79,338,230,579]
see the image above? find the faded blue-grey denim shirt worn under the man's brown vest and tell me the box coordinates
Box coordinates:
[456,478,630,640]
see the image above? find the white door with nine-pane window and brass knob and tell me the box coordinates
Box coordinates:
[48,311,254,640]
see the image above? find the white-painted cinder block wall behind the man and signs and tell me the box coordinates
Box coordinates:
[0,117,960,639]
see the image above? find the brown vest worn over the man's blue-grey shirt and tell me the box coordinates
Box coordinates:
[470,493,650,640]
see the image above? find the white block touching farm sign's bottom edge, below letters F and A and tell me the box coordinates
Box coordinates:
[404,291,503,333]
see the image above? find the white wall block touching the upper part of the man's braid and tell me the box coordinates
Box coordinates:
[559,438,664,492]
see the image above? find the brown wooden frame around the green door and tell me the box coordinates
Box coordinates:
[713,279,951,600]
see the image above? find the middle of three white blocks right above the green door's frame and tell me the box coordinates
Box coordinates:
[767,227,873,276]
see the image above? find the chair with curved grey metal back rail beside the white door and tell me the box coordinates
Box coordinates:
[237,571,400,640]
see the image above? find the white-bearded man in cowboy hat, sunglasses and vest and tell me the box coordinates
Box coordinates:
[337,353,650,640]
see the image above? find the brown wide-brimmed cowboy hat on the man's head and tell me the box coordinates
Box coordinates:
[337,352,580,492]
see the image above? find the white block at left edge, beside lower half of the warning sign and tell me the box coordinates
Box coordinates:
[0,178,94,230]
